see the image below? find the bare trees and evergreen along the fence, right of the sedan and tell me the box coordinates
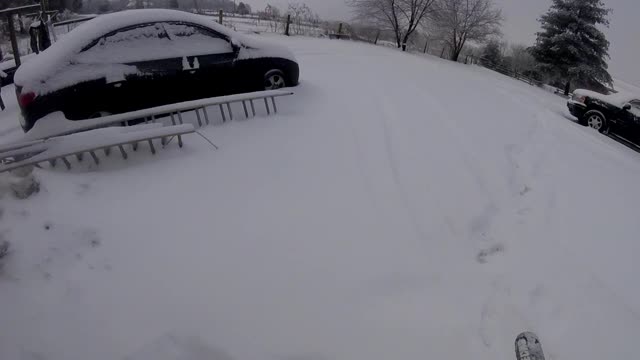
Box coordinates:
[347,0,613,94]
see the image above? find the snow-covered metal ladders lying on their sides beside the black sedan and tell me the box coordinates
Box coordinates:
[0,90,293,173]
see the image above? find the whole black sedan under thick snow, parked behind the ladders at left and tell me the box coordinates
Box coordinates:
[14,9,299,131]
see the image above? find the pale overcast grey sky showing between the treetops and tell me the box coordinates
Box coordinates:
[245,0,640,86]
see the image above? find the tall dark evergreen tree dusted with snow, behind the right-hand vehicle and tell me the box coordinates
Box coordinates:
[531,0,613,91]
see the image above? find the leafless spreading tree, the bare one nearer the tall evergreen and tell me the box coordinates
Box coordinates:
[432,0,503,61]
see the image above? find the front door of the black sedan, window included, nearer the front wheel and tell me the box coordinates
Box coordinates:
[164,22,237,100]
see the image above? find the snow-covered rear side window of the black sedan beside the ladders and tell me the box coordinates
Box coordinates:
[76,23,172,64]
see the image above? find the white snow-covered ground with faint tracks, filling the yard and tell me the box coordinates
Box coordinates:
[0,36,640,360]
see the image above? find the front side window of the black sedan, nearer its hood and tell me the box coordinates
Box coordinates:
[164,23,233,56]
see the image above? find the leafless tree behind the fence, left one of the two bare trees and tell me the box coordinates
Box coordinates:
[347,0,436,51]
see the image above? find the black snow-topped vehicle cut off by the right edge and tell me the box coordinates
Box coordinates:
[567,90,640,142]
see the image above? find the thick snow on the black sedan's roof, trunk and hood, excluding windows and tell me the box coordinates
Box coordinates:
[14,9,295,87]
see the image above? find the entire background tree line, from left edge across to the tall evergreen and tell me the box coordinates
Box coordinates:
[0,0,613,93]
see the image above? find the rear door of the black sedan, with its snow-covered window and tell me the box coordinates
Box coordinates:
[74,22,182,113]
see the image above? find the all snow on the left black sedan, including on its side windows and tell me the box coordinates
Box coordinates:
[14,9,295,95]
